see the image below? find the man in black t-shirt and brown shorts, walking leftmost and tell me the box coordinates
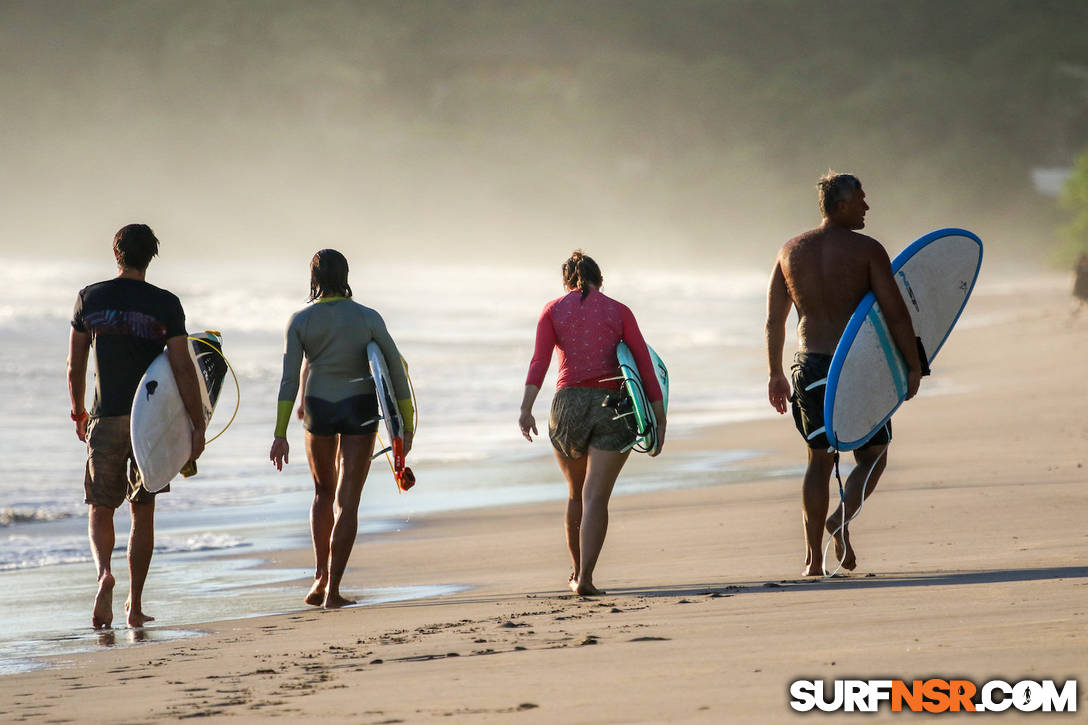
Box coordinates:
[67,224,206,629]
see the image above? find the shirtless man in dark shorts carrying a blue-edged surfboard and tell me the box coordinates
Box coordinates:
[767,172,922,577]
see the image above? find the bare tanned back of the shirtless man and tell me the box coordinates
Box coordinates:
[779,226,888,355]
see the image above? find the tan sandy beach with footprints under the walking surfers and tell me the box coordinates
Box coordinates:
[0,275,1088,723]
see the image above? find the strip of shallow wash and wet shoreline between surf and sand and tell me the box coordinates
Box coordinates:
[0,428,798,677]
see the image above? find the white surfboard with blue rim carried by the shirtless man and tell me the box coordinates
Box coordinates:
[824,229,982,451]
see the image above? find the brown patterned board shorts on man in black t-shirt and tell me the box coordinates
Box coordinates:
[83,416,162,508]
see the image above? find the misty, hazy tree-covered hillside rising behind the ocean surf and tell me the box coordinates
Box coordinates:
[0,0,1088,260]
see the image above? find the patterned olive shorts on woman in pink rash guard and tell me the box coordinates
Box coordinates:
[548,388,634,458]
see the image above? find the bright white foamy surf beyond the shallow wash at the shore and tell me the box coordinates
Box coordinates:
[0,260,783,555]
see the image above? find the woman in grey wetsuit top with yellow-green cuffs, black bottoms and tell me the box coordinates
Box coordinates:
[269,249,413,609]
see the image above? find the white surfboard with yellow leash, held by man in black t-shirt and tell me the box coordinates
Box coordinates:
[129,332,226,493]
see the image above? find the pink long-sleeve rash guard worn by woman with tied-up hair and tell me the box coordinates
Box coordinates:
[526,290,662,403]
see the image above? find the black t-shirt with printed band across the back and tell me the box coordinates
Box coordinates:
[72,277,186,417]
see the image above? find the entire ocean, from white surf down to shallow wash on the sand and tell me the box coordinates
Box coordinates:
[0,259,792,669]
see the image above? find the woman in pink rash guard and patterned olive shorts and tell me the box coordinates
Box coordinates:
[518,250,665,597]
